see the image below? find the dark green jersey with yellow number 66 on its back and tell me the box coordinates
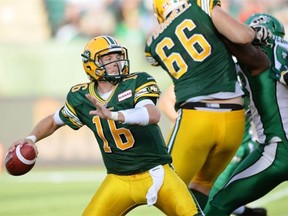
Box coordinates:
[145,0,237,108]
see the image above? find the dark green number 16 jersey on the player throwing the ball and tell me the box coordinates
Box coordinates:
[60,72,172,175]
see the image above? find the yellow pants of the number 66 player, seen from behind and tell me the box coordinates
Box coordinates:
[168,109,245,190]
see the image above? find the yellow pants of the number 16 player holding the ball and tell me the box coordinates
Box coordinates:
[83,165,202,216]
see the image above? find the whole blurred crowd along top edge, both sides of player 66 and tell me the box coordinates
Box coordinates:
[45,0,288,43]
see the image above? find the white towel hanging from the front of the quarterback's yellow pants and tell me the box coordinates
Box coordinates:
[146,165,164,206]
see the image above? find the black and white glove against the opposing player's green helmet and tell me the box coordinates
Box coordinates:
[250,24,273,47]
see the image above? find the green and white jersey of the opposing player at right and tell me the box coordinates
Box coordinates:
[241,37,288,143]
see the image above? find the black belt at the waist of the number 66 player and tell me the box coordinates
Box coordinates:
[180,102,243,110]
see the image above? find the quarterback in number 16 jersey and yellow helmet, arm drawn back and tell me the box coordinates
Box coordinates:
[10,35,203,216]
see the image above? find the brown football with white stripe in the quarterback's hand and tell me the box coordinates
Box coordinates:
[5,143,37,176]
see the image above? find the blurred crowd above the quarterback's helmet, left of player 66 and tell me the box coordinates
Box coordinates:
[46,0,156,43]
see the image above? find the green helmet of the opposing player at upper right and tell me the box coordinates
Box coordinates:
[245,13,285,37]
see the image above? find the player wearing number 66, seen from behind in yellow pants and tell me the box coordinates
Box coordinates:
[145,0,269,211]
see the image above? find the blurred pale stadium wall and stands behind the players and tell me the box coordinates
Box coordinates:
[0,0,288,214]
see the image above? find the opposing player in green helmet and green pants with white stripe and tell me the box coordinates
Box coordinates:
[204,13,288,216]
